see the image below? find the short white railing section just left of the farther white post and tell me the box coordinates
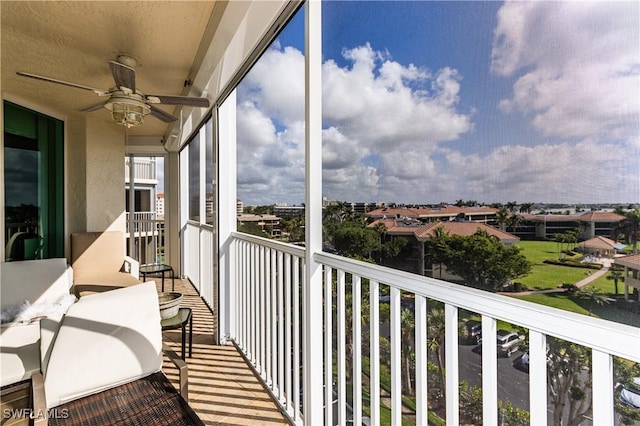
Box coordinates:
[181,222,217,309]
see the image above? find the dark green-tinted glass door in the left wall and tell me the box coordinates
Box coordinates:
[4,102,64,261]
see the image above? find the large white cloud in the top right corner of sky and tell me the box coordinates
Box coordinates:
[492,2,640,142]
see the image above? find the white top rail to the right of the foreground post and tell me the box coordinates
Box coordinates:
[315,252,640,362]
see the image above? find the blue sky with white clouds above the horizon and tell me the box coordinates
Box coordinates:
[238,1,640,204]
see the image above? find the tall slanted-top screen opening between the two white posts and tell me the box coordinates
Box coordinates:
[237,8,305,242]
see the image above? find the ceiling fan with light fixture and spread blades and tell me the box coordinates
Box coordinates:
[16,55,209,128]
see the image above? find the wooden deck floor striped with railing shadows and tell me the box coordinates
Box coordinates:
[156,279,289,426]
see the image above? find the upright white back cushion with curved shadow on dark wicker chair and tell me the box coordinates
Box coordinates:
[44,281,162,408]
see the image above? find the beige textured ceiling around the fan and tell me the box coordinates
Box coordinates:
[0,0,214,135]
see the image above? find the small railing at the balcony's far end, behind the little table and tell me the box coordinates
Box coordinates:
[126,212,165,264]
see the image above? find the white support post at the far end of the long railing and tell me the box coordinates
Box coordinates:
[216,91,237,342]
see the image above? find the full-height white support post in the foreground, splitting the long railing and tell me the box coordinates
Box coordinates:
[302,0,324,425]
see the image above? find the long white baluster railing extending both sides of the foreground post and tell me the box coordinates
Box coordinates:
[228,233,640,425]
